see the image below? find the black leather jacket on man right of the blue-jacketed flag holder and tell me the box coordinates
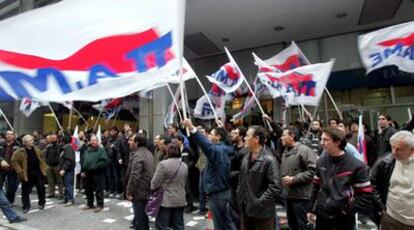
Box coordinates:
[237,147,281,220]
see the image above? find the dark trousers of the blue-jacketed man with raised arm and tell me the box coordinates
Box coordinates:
[208,190,236,230]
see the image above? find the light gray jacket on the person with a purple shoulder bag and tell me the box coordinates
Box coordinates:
[151,158,188,208]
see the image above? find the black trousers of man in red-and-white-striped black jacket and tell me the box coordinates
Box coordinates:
[315,215,355,230]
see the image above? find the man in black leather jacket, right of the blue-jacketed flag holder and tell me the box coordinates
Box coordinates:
[237,126,281,230]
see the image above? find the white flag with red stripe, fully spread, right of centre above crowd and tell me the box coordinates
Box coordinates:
[258,61,334,106]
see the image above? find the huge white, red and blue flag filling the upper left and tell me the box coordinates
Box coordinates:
[0,0,185,102]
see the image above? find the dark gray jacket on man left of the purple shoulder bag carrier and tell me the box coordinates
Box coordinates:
[125,147,155,201]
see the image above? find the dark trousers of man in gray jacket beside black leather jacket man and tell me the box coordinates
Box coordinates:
[286,198,310,230]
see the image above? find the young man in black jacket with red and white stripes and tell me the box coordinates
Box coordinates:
[307,128,375,230]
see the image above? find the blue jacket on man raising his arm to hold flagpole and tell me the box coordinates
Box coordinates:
[191,132,233,194]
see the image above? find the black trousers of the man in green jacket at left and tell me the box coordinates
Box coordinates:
[85,169,105,208]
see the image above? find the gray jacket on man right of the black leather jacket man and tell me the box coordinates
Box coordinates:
[280,142,318,199]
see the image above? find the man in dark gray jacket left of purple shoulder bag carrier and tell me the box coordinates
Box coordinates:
[125,134,155,229]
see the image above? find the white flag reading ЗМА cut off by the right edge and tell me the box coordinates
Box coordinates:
[358,22,414,73]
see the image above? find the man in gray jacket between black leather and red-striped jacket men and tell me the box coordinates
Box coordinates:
[280,127,318,230]
